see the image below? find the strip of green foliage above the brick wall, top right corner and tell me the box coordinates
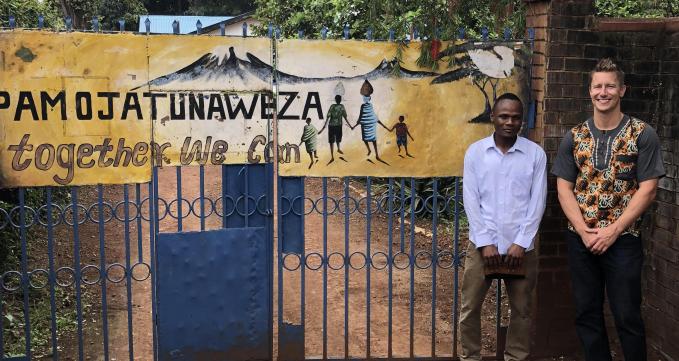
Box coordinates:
[594,0,679,18]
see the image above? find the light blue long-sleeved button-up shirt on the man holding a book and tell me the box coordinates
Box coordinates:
[462,135,547,254]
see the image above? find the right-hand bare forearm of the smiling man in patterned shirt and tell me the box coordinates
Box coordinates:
[590,178,658,254]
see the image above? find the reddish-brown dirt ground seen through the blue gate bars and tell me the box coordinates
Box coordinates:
[13,167,596,361]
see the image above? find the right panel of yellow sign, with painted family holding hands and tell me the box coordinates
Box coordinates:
[278,40,527,177]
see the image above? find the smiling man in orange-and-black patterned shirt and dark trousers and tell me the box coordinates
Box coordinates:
[552,59,665,361]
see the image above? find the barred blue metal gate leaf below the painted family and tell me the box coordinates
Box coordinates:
[278,177,488,360]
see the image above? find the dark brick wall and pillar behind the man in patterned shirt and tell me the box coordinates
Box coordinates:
[526,0,679,360]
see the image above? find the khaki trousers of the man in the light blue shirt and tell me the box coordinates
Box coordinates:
[460,243,537,361]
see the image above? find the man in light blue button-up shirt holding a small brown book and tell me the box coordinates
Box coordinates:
[460,93,547,361]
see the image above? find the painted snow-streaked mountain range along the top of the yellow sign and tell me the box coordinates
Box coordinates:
[133,47,440,90]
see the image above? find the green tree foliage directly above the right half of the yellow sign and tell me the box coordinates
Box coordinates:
[256,0,525,39]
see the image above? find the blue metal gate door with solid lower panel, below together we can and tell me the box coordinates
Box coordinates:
[156,164,273,361]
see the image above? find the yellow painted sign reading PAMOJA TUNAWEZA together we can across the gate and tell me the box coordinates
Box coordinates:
[0,31,526,187]
